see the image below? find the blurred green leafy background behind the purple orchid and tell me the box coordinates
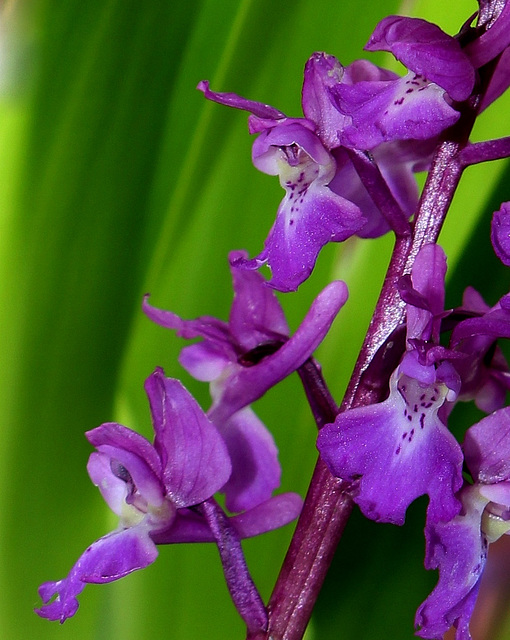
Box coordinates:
[0,0,510,640]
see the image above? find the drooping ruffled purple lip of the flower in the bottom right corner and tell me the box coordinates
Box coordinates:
[415,487,487,640]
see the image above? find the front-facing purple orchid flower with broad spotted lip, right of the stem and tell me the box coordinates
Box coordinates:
[317,245,463,524]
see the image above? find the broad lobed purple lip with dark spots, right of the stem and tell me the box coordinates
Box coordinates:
[317,360,463,524]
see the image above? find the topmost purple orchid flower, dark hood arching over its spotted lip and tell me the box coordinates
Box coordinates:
[331,16,475,149]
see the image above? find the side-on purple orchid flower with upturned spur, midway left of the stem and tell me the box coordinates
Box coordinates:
[143,252,347,511]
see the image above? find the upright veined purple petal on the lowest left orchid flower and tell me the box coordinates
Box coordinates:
[145,369,232,507]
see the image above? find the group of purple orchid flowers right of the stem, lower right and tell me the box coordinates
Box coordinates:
[317,244,510,640]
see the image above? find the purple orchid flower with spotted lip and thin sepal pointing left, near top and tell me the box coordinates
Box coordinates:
[198,53,433,291]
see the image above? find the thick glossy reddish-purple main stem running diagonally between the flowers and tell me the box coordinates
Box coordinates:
[248,2,510,640]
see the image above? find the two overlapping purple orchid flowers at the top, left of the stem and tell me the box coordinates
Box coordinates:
[198,16,482,291]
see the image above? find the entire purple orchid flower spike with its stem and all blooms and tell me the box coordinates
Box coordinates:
[36,0,510,640]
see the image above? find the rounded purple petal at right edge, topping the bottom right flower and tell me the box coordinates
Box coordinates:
[464,407,510,484]
